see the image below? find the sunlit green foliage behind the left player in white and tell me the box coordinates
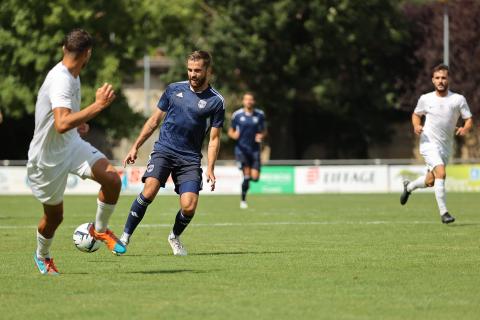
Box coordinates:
[0,0,153,138]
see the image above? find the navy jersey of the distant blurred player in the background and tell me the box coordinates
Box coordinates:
[230,108,265,153]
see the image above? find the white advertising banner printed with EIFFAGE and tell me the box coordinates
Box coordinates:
[295,165,388,193]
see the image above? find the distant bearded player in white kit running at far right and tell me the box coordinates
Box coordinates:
[400,64,473,223]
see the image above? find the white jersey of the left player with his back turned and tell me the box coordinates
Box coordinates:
[28,62,81,167]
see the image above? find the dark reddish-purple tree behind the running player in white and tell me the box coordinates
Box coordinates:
[400,0,480,159]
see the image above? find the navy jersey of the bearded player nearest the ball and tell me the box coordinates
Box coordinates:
[153,81,225,163]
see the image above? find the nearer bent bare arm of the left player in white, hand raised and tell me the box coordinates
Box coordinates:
[53,83,115,133]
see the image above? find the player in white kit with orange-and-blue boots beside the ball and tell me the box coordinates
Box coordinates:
[27,29,126,275]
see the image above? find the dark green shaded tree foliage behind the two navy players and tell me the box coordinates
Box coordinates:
[163,0,410,158]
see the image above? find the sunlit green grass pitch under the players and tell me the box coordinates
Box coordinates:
[0,193,480,319]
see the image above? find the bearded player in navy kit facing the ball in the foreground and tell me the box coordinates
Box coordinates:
[120,51,225,256]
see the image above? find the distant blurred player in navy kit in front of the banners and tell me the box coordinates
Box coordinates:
[228,92,266,209]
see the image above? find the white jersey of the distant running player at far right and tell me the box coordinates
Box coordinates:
[414,91,472,155]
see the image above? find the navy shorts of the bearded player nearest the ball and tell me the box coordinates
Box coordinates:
[142,152,203,194]
